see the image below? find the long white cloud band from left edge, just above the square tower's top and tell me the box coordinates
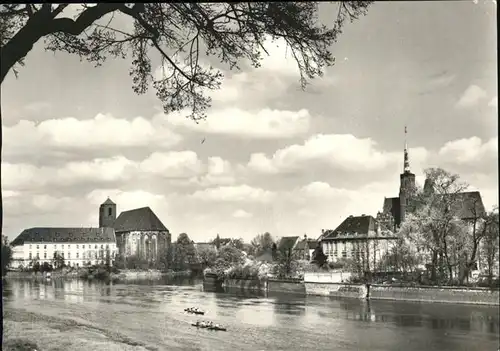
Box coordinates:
[2,151,231,191]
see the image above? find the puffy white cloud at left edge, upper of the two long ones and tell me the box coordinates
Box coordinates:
[4,114,182,162]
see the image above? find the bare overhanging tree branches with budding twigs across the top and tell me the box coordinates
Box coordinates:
[0,1,372,236]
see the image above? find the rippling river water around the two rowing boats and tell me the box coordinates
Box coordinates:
[3,279,499,351]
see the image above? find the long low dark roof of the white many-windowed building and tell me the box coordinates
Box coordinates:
[11,227,115,246]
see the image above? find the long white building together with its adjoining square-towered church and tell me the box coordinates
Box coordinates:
[11,198,171,268]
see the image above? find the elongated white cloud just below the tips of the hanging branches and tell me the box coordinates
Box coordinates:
[166,108,311,139]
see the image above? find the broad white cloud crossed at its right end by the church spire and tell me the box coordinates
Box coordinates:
[248,134,427,173]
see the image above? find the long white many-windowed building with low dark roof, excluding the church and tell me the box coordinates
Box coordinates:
[11,228,117,268]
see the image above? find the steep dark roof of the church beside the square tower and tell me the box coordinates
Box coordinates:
[114,207,168,233]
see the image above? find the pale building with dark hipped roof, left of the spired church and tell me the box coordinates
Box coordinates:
[320,214,397,267]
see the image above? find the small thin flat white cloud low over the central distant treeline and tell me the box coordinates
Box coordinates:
[192,184,274,203]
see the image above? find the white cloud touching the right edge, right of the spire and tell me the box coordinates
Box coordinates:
[439,136,498,164]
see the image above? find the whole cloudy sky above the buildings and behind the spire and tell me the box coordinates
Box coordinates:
[1,1,498,242]
